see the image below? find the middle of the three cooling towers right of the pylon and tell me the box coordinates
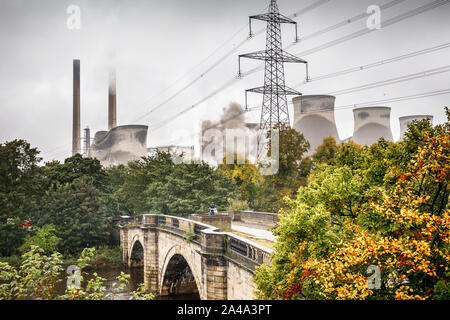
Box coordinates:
[353,107,393,145]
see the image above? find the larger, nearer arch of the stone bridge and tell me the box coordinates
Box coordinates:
[159,245,203,299]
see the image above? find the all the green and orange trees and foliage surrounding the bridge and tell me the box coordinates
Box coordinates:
[0,104,450,299]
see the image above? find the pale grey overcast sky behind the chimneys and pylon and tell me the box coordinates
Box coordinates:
[0,0,450,161]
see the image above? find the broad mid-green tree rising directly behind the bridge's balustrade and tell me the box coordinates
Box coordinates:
[114,152,235,215]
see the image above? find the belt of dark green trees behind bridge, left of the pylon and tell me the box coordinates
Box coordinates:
[0,146,235,256]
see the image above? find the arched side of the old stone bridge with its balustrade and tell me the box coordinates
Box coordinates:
[120,214,272,300]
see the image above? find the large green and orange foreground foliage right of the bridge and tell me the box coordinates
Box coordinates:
[255,109,450,300]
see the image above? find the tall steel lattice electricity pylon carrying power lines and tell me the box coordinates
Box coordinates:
[239,0,308,133]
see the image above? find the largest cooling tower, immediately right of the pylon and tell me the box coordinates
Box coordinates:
[292,95,340,156]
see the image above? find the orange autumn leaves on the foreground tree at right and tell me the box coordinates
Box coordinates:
[285,130,450,299]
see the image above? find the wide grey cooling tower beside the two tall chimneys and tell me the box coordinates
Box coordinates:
[90,125,148,166]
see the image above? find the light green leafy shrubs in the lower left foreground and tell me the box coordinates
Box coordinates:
[0,245,154,300]
